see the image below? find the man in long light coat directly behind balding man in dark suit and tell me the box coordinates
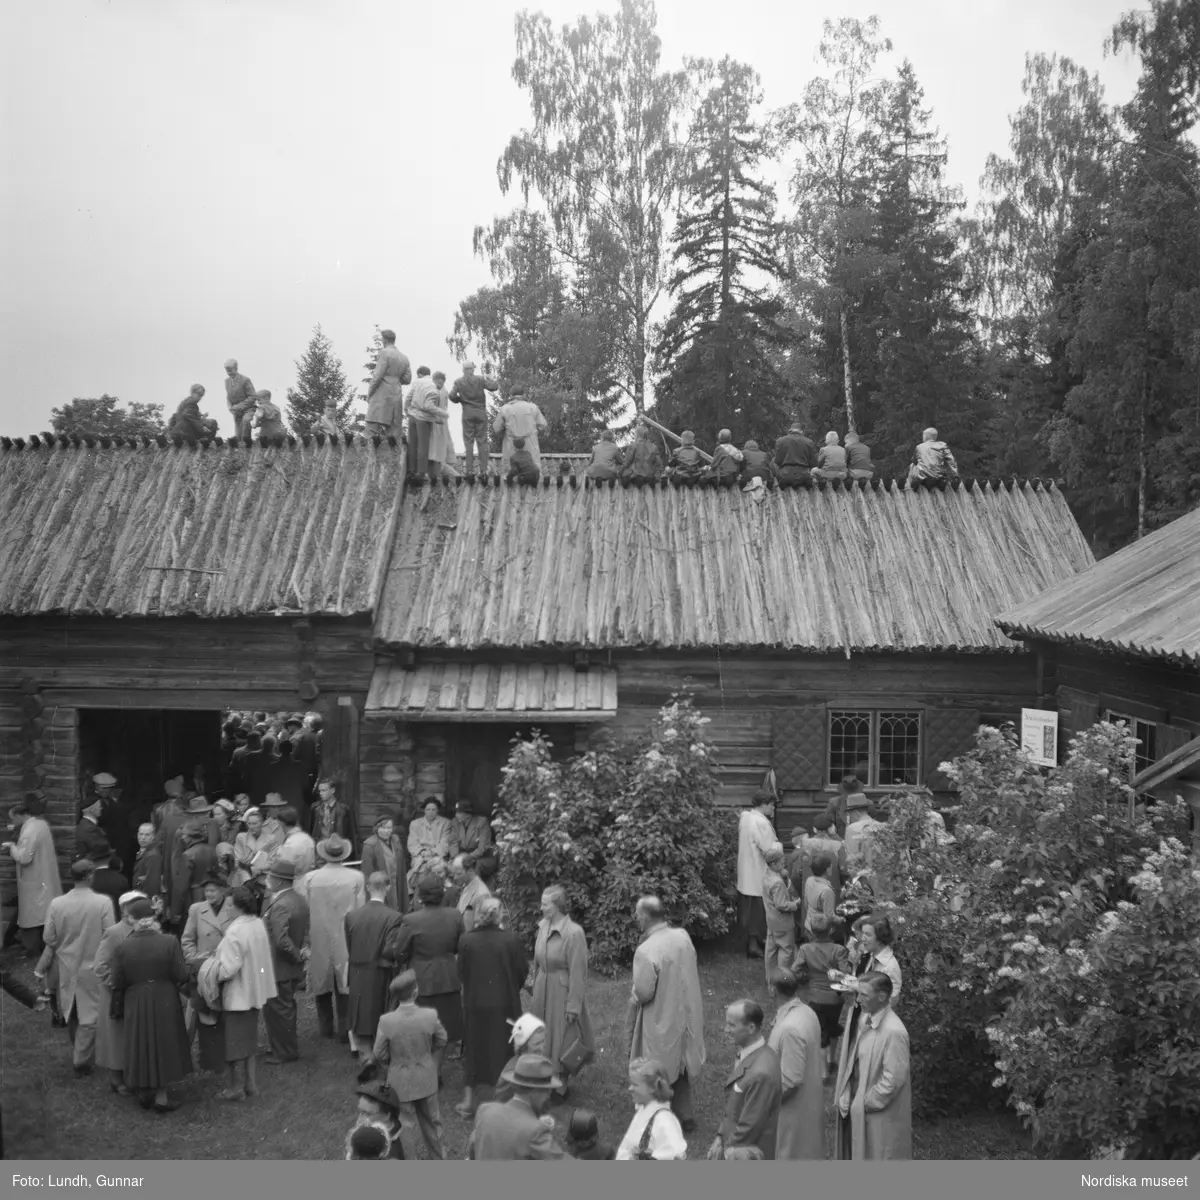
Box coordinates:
[767,970,824,1160]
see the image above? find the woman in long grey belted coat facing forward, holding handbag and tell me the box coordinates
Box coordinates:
[529,884,595,1099]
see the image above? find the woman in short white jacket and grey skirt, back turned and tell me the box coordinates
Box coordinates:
[216,886,277,1100]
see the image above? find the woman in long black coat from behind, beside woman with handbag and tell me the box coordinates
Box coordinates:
[457,896,529,1117]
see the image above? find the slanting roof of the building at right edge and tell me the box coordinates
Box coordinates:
[997,509,1200,666]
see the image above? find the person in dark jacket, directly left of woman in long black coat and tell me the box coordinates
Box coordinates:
[384,875,467,1075]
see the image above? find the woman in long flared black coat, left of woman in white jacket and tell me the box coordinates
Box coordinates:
[112,900,192,1112]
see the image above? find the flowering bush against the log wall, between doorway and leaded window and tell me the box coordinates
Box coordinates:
[493,700,737,966]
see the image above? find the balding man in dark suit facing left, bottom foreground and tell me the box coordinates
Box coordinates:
[707,1000,784,1158]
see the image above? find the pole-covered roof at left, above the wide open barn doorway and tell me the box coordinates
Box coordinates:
[0,437,403,617]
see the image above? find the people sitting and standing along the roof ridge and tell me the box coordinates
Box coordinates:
[168,345,959,491]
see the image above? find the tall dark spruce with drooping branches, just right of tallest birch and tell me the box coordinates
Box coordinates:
[655,56,790,442]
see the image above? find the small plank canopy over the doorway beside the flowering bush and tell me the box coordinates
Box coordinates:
[366,662,617,725]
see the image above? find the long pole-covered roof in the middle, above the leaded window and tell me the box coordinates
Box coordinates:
[376,472,1093,653]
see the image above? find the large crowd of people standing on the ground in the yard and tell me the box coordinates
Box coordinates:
[5,734,911,1160]
